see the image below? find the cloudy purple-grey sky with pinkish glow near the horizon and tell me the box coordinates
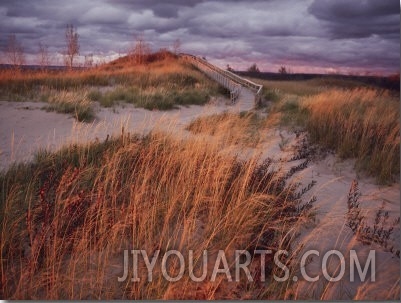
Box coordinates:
[0,0,400,74]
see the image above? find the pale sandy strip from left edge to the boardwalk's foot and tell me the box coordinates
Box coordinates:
[0,89,253,170]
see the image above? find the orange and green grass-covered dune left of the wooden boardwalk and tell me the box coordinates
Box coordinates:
[0,55,223,114]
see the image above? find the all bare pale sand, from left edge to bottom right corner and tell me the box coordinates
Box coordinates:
[0,96,400,300]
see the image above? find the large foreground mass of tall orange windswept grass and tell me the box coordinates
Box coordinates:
[0,133,310,299]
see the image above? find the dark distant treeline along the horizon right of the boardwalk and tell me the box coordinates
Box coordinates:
[235,71,400,91]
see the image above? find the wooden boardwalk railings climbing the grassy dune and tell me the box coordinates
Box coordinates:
[180,54,263,104]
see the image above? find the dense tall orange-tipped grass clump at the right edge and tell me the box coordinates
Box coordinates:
[302,88,400,182]
